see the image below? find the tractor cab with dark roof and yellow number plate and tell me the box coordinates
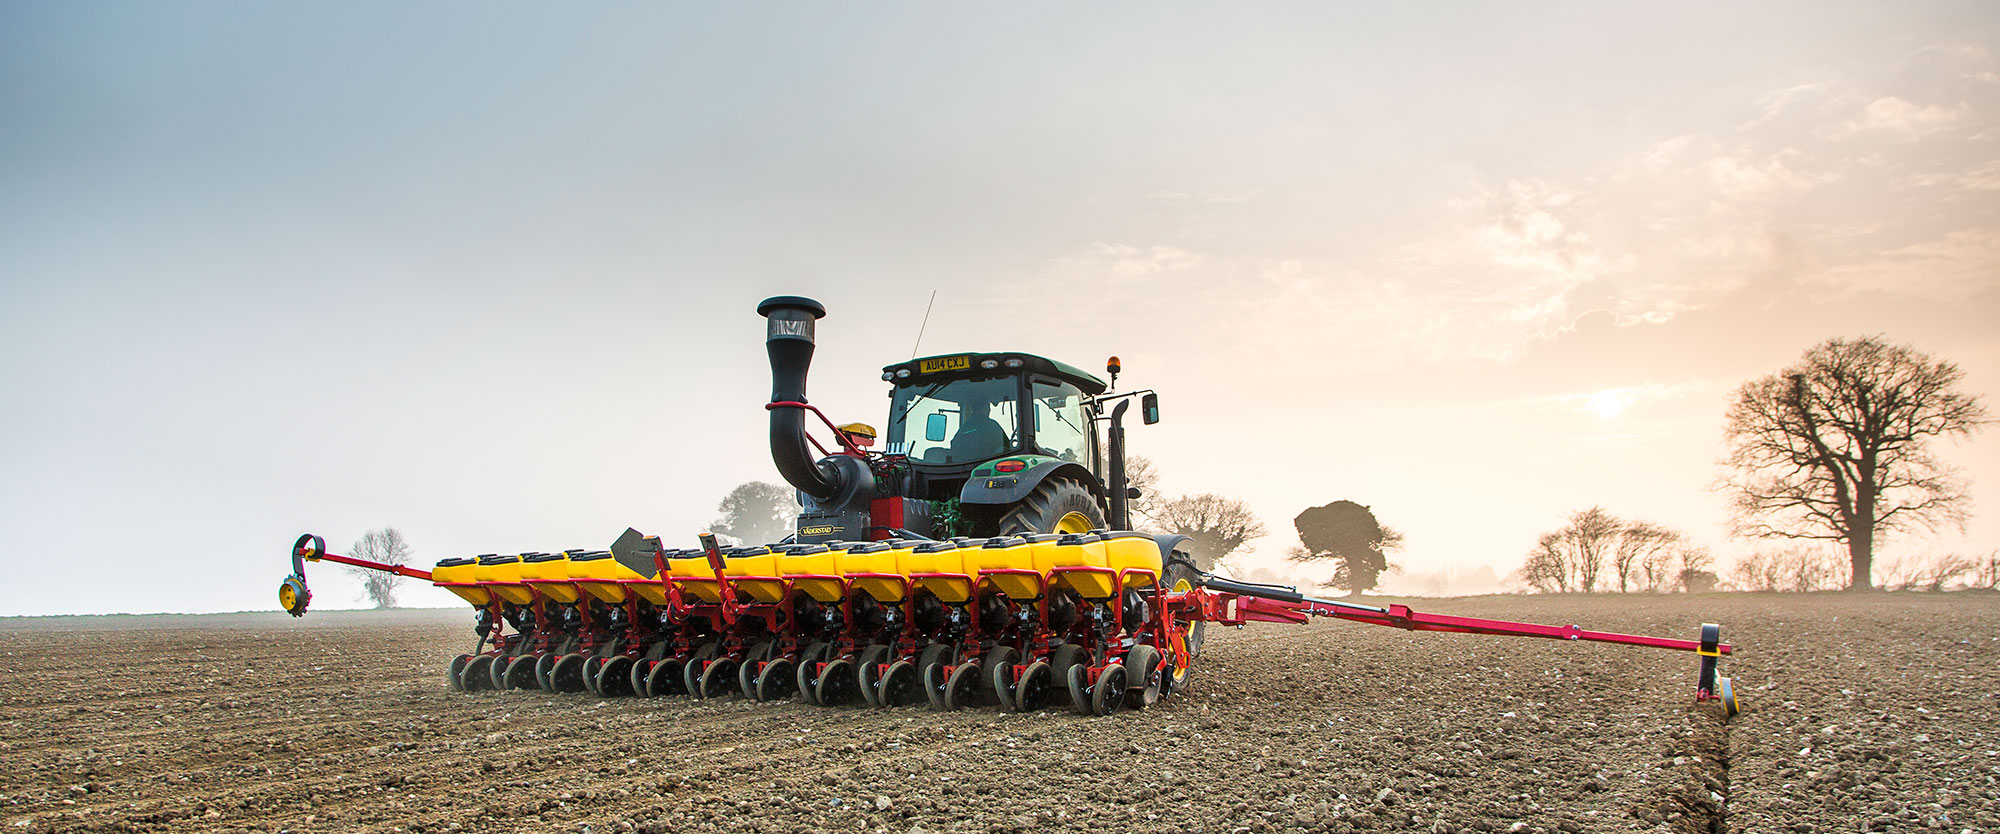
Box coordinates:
[882,354,1104,500]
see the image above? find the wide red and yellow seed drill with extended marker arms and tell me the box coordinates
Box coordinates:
[280,530,1736,716]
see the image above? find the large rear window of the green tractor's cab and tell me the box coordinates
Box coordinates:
[884,376,1020,466]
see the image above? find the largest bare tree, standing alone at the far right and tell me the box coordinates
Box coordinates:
[1722,336,1986,590]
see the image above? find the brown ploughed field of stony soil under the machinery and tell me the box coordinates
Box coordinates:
[0,594,2000,834]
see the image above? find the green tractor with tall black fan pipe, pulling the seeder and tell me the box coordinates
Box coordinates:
[758,296,1164,544]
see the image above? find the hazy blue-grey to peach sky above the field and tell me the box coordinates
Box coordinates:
[0,0,2000,616]
